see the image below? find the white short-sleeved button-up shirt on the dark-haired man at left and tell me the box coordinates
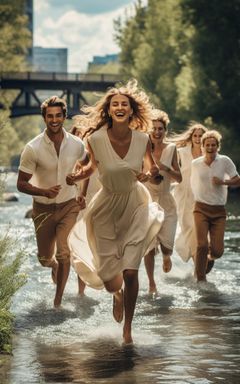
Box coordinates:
[19,128,86,204]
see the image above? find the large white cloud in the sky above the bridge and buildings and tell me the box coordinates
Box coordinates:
[34,0,146,72]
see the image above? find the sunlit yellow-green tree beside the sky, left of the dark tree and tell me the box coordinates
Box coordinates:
[115,0,194,124]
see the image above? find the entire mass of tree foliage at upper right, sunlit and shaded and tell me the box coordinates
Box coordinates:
[115,0,240,141]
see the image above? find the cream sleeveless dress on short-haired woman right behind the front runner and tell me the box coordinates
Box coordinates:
[145,143,177,250]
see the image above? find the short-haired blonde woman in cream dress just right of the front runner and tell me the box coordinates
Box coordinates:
[144,109,182,294]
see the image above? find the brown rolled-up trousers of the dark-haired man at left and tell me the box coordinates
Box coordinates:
[32,199,80,267]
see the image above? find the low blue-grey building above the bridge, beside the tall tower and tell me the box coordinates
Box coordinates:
[33,47,68,73]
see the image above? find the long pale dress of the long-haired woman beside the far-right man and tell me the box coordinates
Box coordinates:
[173,145,197,262]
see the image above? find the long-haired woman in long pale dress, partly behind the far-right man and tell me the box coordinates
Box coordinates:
[171,122,207,262]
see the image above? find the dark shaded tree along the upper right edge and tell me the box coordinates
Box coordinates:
[182,0,240,129]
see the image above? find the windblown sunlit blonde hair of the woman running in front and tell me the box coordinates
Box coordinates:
[82,79,152,135]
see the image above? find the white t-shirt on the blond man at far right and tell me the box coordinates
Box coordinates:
[191,154,238,205]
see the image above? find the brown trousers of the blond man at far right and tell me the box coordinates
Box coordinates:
[193,202,226,280]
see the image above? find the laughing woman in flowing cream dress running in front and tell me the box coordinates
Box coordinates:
[67,81,163,344]
